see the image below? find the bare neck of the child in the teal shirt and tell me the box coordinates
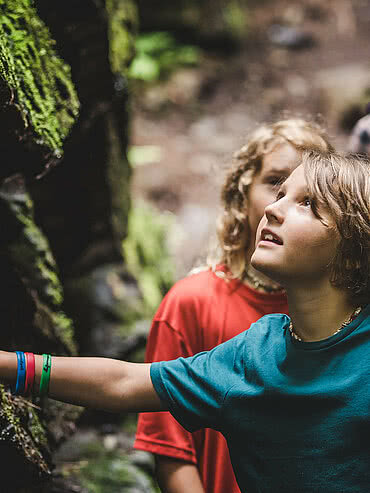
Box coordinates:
[287,281,356,342]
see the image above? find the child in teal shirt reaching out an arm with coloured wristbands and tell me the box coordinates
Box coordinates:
[0,152,370,493]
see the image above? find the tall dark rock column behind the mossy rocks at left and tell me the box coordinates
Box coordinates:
[29,0,142,356]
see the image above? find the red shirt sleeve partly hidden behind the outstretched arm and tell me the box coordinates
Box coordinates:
[134,319,197,464]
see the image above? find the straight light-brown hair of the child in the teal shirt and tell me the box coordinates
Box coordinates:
[302,151,370,305]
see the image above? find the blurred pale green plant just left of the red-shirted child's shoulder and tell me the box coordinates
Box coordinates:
[123,203,174,318]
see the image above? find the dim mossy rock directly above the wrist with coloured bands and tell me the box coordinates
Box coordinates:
[0,185,76,354]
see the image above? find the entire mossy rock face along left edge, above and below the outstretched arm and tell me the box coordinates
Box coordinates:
[0,0,79,491]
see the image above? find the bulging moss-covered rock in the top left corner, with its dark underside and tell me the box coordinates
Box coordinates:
[0,0,79,178]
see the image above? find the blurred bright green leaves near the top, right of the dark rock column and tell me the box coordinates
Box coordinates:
[129,31,201,82]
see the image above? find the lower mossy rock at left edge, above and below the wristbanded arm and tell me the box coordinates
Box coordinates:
[0,183,79,486]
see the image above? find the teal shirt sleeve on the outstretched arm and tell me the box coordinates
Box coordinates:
[150,332,245,432]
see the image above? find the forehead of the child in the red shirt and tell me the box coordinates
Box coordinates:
[261,143,301,175]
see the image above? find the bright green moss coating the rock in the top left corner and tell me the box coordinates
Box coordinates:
[0,0,79,157]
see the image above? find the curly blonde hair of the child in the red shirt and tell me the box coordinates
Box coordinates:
[207,118,333,279]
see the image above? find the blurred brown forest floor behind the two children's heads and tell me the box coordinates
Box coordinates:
[131,0,370,277]
